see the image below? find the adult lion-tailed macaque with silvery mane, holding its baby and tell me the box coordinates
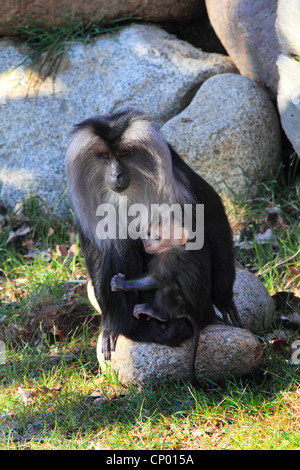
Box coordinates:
[66,111,241,359]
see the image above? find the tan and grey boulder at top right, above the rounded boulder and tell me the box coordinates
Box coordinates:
[206,0,285,97]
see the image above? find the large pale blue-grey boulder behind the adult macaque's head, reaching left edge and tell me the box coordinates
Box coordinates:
[0,25,236,210]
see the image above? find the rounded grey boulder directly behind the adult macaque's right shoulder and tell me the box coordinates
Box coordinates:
[161,74,281,197]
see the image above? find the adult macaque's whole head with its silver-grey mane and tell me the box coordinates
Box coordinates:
[67,111,171,206]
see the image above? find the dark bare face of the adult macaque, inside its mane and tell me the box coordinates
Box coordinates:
[99,150,130,193]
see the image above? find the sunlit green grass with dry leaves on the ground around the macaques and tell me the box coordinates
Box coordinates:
[0,164,300,450]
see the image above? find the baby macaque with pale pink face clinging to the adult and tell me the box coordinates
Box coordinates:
[111,219,207,386]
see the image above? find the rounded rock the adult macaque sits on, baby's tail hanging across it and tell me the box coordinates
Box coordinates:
[97,325,263,386]
